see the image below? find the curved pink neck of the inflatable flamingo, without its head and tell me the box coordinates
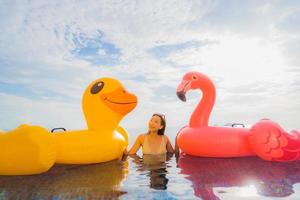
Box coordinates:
[190,78,216,127]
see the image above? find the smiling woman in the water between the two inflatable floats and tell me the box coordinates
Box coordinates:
[128,113,174,155]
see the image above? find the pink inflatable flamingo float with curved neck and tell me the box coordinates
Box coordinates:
[177,72,300,162]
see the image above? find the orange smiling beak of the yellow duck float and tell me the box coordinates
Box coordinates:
[100,87,137,115]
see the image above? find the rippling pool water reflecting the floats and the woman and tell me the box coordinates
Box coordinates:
[0,154,300,200]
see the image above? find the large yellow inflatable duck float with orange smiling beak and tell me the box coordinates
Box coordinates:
[0,78,137,175]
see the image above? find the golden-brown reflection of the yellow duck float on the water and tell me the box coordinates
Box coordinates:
[0,161,128,199]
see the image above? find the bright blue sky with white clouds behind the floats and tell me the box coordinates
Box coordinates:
[0,0,300,141]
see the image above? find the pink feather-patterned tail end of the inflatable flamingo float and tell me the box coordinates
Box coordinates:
[249,119,300,162]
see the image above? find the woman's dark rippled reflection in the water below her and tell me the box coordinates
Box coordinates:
[130,154,173,190]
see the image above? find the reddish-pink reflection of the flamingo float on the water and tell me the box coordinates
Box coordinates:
[178,154,300,200]
